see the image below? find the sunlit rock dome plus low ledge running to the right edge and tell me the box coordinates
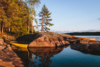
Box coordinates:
[29,32,100,47]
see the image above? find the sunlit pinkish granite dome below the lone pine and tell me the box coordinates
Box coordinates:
[28,32,69,47]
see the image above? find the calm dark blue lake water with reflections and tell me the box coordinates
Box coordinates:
[15,36,100,67]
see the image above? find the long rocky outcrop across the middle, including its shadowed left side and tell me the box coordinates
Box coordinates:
[3,32,100,47]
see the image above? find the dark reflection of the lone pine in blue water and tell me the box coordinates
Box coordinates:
[29,55,52,67]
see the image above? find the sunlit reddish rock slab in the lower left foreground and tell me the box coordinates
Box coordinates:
[0,38,25,67]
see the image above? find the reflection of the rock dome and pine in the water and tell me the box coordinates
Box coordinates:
[29,46,68,67]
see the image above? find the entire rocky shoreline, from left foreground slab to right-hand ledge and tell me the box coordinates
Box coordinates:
[0,32,100,67]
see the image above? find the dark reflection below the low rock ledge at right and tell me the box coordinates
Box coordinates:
[70,44,100,55]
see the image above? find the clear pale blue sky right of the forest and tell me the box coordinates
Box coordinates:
[35,0,100,32]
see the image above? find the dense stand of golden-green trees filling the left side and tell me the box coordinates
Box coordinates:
[0,0,40,36]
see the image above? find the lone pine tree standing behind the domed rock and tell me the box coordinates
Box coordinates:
[39,5,53,32]
